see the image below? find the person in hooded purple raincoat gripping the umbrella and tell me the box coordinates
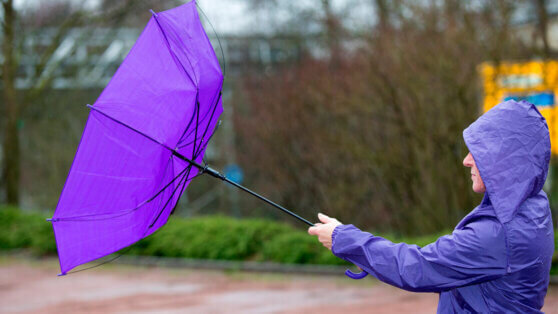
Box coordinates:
[308,100,554,313]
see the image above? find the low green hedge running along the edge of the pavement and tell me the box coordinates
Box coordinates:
[0,206,558,275]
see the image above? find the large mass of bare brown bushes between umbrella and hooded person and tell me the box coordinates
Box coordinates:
[237,0,533,234]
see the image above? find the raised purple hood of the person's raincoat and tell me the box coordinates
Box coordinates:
[463,100,550,223]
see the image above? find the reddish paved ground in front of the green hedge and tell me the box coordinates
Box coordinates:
[0,257,558,314]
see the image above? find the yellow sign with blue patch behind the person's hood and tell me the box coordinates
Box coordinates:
[480,61,558,155]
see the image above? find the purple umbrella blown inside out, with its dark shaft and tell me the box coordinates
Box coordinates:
[49,1,370,275]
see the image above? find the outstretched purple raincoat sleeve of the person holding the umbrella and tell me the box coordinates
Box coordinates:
[332,219,507,292]
